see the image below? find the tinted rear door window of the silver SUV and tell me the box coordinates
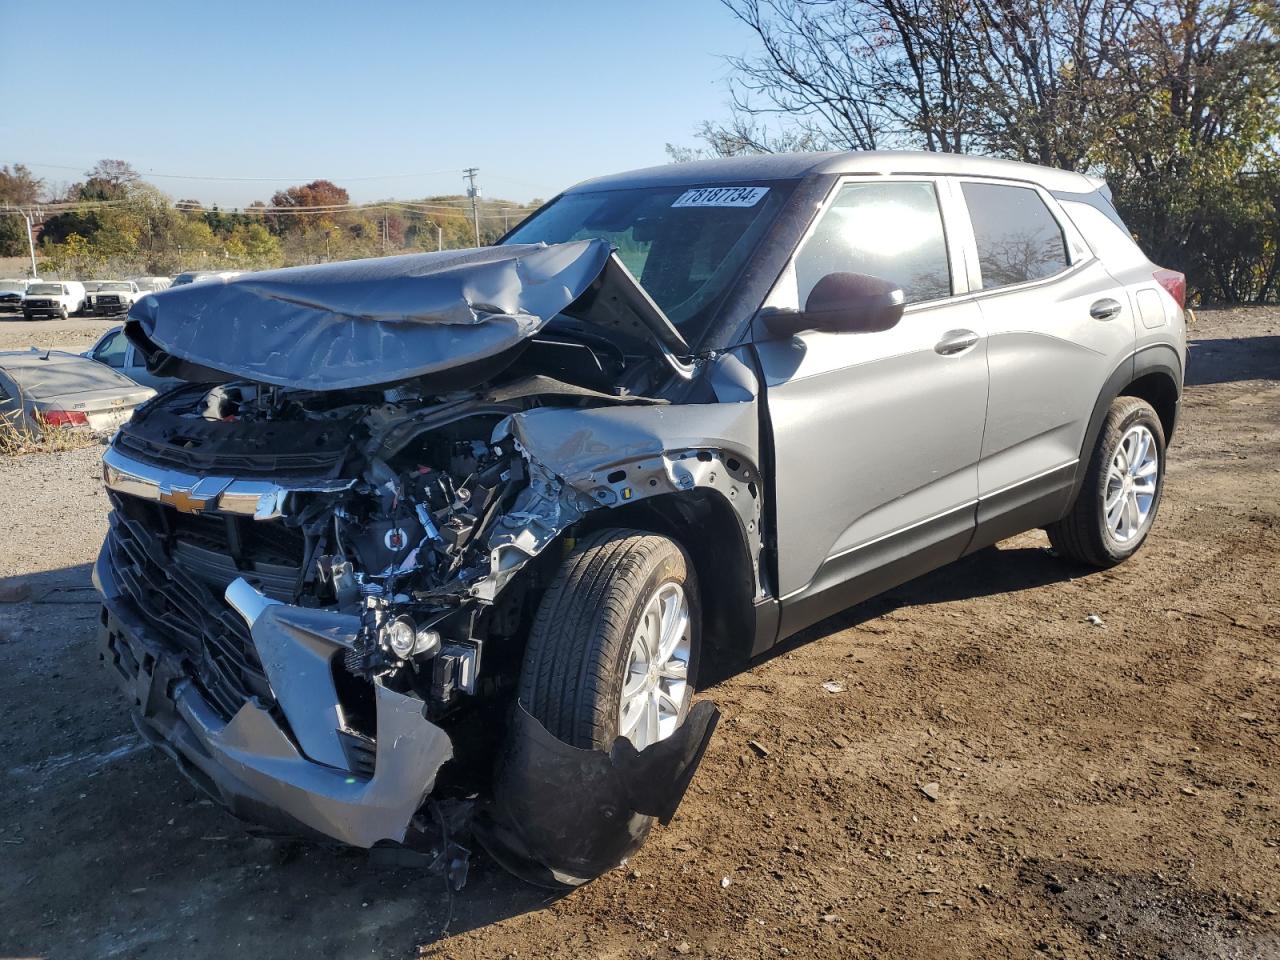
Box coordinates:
[963,182,1070,291]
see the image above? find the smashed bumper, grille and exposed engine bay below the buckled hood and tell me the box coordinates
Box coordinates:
[95,383,588,847]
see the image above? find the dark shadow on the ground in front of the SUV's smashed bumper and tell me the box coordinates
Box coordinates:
[0,564,554,960]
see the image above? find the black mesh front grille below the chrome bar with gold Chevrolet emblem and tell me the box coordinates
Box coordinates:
[108,494,302,721]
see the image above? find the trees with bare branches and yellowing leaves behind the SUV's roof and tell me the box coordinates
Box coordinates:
[691,0,1280,300]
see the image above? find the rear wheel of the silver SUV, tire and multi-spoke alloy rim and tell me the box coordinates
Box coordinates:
[1044,397,1166,567]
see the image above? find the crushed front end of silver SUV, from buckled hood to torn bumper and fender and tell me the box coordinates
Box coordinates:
[93,241,742,881]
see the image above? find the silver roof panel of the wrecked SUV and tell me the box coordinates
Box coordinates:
[564,150,1101,193]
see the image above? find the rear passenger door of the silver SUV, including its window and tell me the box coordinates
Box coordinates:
[957,178,1134,545]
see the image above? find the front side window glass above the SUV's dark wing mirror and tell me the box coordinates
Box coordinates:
[795,180,951,307]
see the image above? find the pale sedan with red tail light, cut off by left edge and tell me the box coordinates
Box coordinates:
[0,348,155,431]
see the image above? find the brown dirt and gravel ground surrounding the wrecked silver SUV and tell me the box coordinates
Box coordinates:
[0,310,1280,960]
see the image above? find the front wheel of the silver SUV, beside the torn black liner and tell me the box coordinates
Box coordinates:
[518,529,701,750]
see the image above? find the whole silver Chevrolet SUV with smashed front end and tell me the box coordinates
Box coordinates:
[95,154,1187,883]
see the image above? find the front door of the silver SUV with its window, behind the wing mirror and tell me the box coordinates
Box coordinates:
[756,177,987,634]
